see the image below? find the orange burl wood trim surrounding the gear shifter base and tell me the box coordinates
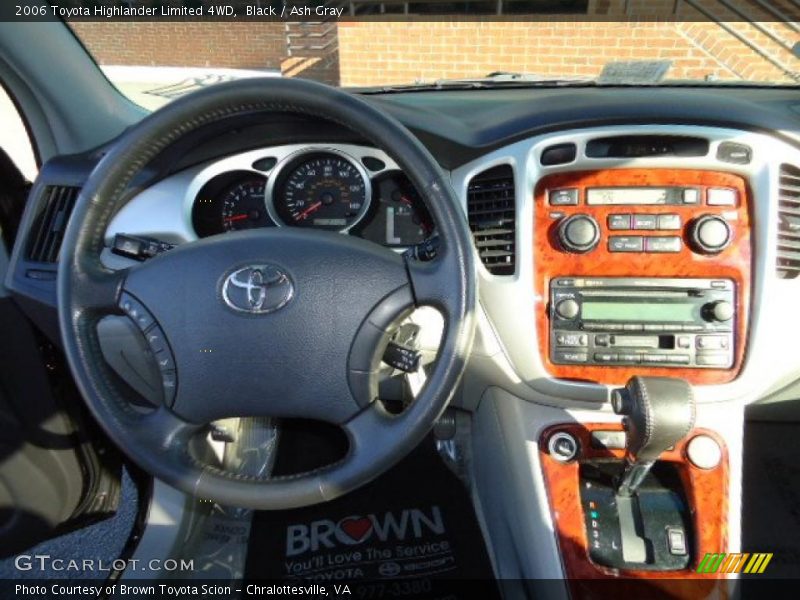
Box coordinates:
[539,423,728,600]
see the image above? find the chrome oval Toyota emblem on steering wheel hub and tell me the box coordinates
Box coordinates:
[222,264,294,315]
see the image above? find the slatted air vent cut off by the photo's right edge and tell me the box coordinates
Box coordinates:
[777,165,800,279]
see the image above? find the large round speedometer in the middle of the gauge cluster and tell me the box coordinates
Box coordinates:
[268,152,370,231]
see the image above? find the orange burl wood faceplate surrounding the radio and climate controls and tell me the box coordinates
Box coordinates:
[533,169,752,384]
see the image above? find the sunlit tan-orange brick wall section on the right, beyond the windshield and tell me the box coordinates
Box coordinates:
[339,17,800,86]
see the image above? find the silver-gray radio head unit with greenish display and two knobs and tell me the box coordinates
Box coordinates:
[549,277,737,369]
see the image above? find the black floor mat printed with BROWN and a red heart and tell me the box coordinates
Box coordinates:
[245,438,496,598]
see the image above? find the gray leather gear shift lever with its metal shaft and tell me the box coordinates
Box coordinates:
[611,376,695,497]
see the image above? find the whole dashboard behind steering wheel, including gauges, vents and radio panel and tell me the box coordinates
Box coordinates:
[9,89,800,407]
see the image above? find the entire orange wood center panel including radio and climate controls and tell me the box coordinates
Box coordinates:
[534,169,751,384]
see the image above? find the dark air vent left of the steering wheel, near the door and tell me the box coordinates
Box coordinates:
[28,186,80,263]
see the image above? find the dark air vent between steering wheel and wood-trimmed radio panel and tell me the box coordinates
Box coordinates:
[467,165,516,275]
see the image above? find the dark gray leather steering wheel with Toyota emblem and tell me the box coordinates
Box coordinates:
[58,78,476,509]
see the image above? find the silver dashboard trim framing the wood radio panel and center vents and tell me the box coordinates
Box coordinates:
[451,125,800,406]
